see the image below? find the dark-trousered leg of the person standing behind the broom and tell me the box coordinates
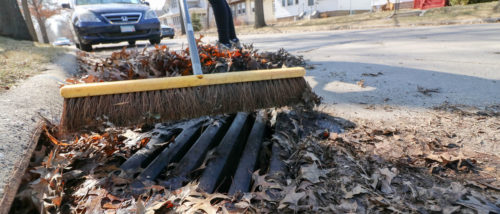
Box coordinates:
[208,0,230,46]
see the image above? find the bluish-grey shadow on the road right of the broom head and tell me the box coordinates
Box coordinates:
[307,61,500,107]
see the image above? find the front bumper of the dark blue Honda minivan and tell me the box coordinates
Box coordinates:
[75,19,161,44]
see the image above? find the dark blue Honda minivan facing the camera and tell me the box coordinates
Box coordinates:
[62,0,161,51]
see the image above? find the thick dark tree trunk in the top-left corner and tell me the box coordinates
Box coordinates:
[0,0,33,40]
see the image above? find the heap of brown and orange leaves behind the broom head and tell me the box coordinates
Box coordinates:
[67,37,306,83]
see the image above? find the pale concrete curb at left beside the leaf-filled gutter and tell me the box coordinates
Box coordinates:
[0,52,76,213]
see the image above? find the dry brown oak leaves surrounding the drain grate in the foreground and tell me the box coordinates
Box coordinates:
[13,111,500,213]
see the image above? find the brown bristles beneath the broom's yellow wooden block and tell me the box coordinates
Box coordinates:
[61,77,315,131]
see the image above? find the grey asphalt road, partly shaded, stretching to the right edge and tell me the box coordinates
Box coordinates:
[96,24,500,117]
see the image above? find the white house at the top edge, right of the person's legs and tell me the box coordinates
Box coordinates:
[274,0,372,21]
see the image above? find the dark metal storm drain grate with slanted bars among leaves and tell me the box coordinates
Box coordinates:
[116,111,282,195]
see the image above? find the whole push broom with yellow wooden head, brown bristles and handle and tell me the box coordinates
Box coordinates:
[60,0,312,131]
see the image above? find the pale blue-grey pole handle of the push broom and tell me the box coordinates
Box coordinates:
[179,0,203,75]
